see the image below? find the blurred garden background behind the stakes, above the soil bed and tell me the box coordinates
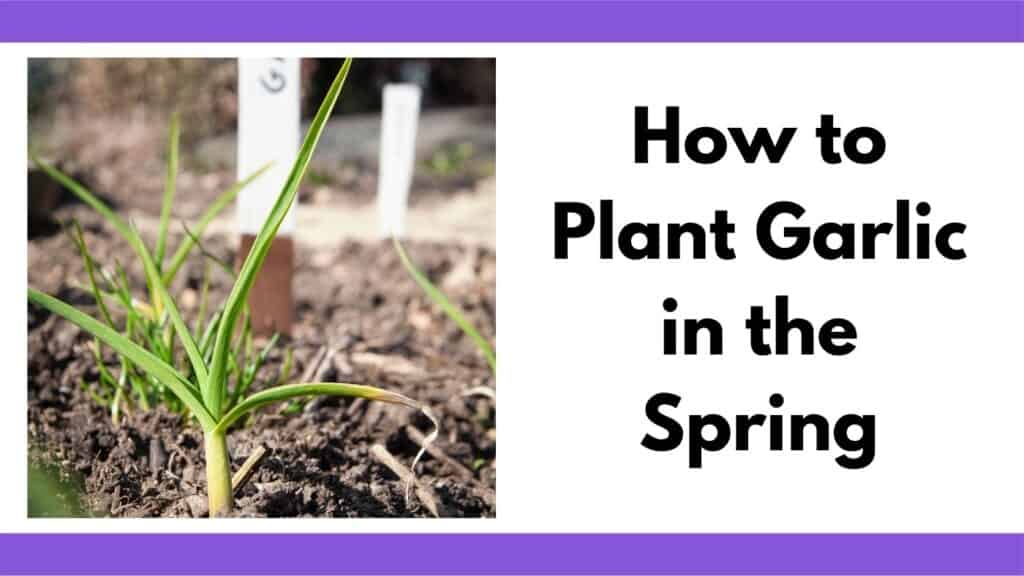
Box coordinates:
[29,58,496,247]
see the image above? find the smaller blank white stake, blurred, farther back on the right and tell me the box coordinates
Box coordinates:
[377,84,420,238]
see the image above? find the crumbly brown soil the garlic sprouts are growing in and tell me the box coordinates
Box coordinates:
[28,206,496,517]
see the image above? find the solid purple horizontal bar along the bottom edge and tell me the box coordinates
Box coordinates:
[0,534,1024,575]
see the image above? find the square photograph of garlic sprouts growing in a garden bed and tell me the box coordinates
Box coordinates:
[27,54,497,518]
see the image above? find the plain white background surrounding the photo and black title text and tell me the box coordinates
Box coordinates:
[0,44,1024,532]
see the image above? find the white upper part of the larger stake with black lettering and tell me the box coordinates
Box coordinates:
[238,58,301,236]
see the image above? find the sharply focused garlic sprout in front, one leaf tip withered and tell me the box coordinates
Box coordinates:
[29,58,437,517]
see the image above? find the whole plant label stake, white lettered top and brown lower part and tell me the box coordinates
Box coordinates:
[238,58,301,335]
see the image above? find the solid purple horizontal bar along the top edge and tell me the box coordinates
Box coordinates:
[0,0,1024,42]
